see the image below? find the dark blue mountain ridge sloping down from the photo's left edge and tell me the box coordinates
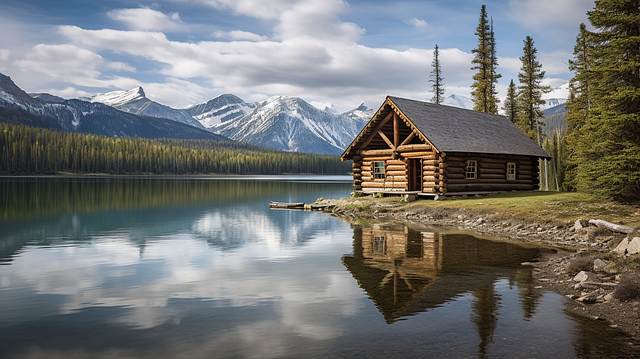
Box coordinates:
[0,74,225,140]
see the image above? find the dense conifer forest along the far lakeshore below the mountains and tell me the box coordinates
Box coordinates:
[0,123,351,174]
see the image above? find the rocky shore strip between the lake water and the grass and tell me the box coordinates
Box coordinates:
[316,198,640,343]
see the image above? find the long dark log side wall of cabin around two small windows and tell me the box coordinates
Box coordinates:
[445,154,538,192]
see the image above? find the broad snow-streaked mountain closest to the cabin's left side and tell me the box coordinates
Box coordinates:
[213,96,366,155]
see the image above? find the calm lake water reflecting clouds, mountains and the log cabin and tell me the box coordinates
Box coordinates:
[0,176,630,359]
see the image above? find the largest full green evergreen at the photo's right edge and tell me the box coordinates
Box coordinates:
[571,0,640,199]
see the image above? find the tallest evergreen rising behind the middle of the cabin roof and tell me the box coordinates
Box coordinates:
[471,5,501,113]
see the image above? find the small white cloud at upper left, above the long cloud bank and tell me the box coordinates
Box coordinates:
[107,8,183,31]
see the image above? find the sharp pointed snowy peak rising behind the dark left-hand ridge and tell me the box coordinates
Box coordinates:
[90,87,204,128]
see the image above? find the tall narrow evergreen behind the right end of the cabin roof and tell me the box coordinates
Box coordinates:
[518,36,551,145]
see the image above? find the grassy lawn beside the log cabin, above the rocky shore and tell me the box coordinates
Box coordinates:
[356,191,640,227]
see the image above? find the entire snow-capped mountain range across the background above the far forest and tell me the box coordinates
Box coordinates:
[0,74,565,155]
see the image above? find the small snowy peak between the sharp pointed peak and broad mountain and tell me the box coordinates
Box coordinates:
[185,94,258,128]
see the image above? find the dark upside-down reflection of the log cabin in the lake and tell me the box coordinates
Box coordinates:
[342,223,542,323]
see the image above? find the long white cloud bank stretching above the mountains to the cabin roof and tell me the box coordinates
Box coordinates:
[59,26,472,107]
